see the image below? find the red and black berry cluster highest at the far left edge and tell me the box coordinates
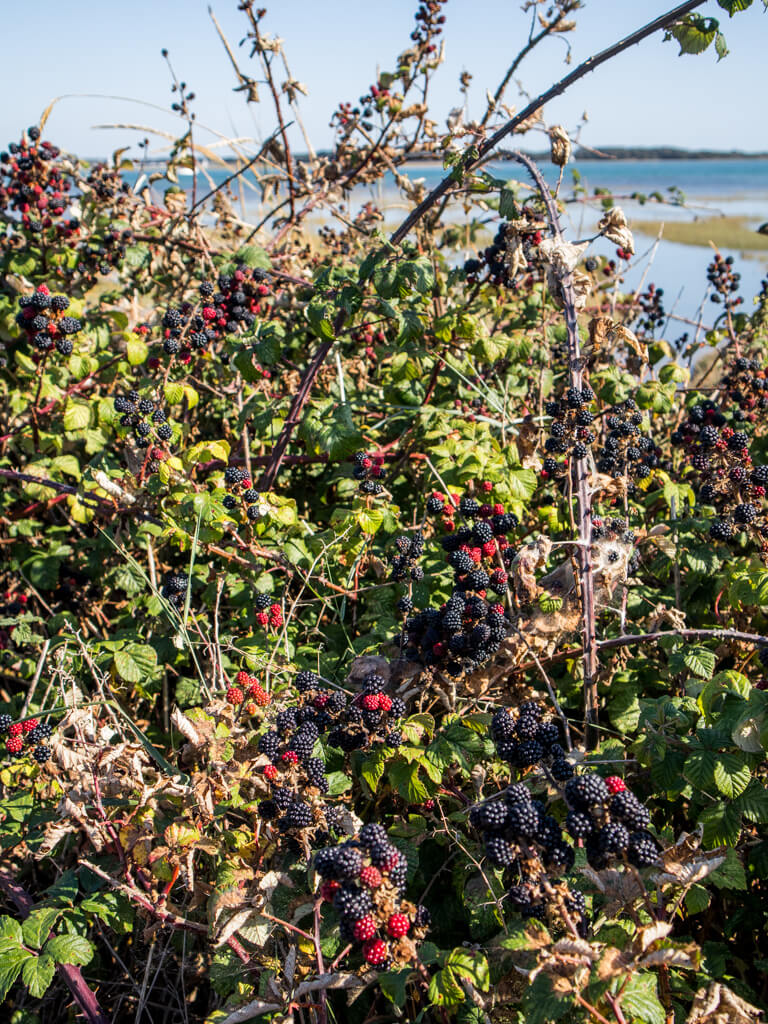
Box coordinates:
[0,128,72,233]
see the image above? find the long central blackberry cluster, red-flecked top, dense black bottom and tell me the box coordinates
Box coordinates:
[394,493,517,676]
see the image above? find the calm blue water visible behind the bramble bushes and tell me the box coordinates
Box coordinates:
[127,159,768,323]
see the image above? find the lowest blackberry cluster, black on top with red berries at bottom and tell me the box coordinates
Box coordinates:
[314,824,430,970]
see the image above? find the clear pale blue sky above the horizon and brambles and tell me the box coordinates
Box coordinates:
[0,0,768,156]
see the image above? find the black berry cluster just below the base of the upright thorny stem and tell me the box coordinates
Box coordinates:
[490,700,573,782]
